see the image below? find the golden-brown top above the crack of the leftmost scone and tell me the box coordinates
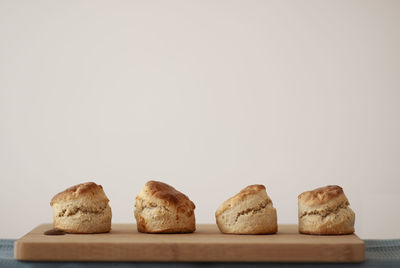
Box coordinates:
[50,182,109,206]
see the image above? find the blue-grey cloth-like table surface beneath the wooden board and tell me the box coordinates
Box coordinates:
[0,239,400,267]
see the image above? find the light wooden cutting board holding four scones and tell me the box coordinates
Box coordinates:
[14,224,365,262]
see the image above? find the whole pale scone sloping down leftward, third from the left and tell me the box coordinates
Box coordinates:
[215,185,278,234]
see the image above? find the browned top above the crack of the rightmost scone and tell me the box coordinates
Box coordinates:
[298,185,348,206]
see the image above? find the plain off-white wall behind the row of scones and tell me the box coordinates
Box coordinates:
[0,0,400,238]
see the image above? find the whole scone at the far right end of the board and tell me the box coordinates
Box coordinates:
[298,185,355,235]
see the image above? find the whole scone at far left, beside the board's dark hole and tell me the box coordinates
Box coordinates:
[50,182,111,234]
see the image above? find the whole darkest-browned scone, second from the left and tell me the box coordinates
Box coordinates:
[134,181,196,233]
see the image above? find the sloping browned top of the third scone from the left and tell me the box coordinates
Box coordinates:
[215,184,272,216]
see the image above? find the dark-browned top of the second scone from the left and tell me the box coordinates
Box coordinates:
[137,180,195,210]
